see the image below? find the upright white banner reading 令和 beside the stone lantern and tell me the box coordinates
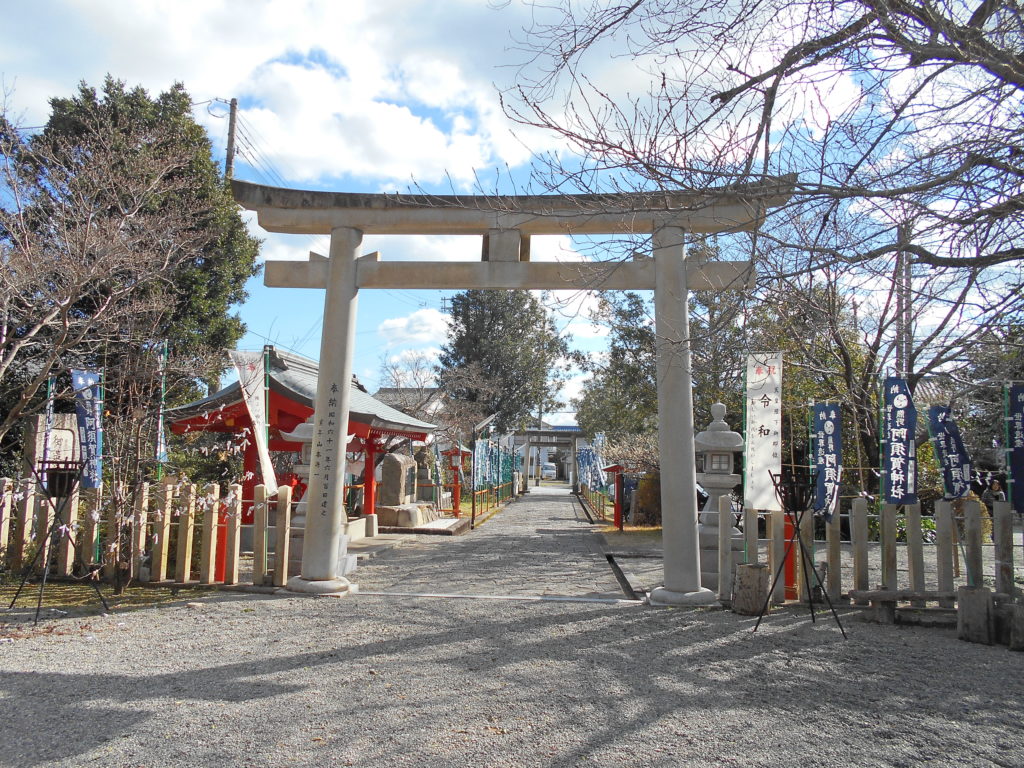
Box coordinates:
[743,352,782,510]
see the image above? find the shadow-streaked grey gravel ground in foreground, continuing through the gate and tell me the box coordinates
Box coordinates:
[0,489,1024,768]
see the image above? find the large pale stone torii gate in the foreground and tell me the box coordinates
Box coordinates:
[231,178,794,604]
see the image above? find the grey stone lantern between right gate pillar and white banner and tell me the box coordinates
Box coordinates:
[693,402,743,590]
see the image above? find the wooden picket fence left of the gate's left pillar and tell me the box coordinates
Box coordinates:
[0,478,297,586]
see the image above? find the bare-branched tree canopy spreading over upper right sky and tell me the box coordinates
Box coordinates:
[504,0,1024,481]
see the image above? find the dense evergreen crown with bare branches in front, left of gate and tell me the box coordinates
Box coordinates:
[0,77,258,475]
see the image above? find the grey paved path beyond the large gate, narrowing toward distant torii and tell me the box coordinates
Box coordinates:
[351,486,626,599]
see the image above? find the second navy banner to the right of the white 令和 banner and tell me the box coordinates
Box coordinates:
[882,376,918,504]
